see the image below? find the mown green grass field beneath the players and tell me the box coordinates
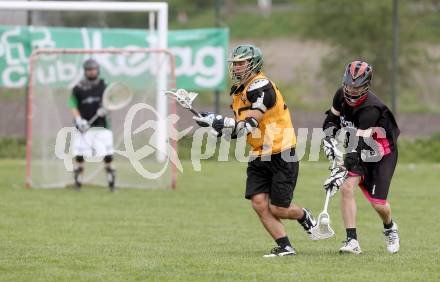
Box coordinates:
[0,160,440,281]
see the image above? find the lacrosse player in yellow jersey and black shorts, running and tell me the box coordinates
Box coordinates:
[193,44,316,257]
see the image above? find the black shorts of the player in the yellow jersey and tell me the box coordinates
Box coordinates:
[245,149,299,208]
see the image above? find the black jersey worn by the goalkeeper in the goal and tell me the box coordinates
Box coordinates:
[72,79,108,128]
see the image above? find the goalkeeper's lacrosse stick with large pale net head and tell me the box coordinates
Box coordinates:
[89,82,133,125]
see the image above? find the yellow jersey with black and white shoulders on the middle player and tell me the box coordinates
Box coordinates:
[231,72,296,155]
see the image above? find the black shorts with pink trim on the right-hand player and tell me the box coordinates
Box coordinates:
[349,148,398,204]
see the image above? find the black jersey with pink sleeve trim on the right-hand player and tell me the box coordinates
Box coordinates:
[333,87,400,155]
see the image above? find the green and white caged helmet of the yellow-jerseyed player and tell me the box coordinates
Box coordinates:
[228,45,263,84]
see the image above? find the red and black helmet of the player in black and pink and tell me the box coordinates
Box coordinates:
[342,61,373,107]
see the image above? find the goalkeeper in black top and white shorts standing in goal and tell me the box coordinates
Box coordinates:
[69,59,115,191]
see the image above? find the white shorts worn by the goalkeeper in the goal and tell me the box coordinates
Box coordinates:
[72,127,114,157]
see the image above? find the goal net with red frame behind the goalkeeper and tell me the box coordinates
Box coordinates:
[26,49,176,188]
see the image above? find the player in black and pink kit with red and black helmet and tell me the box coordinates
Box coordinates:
[323,61,400,254]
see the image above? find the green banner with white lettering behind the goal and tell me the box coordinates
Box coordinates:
[0,26,229,91]
